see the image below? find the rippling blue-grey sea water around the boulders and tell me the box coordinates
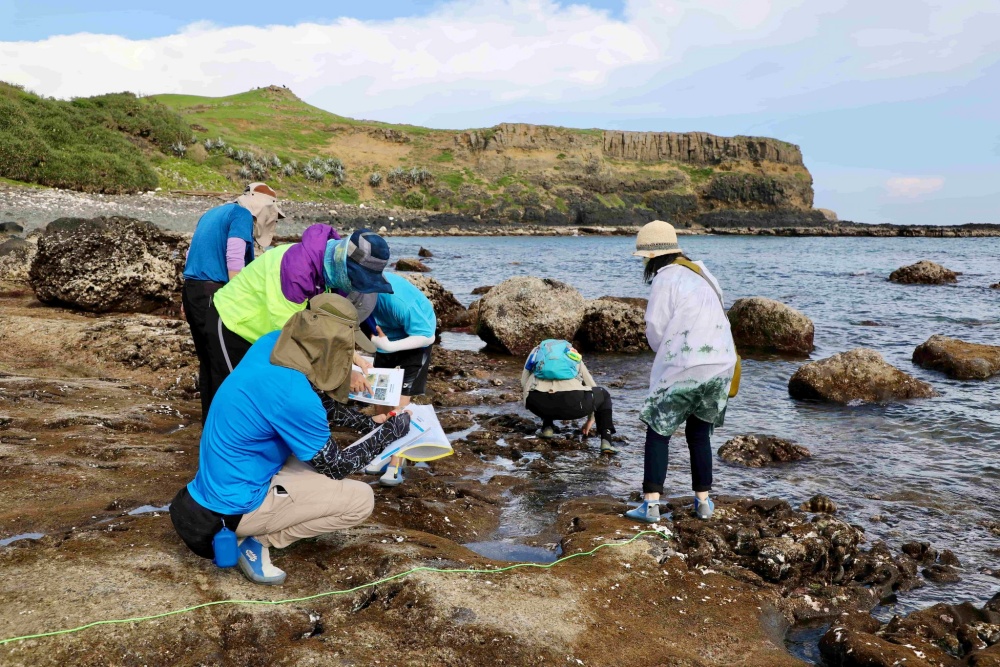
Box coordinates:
[390,236,1000,616]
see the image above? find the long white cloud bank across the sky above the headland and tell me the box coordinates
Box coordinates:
[0,0,1000,126]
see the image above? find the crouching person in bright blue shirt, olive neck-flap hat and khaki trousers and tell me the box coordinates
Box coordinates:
[170,294,410,584]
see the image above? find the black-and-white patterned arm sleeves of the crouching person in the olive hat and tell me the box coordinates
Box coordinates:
[309,397,410,479]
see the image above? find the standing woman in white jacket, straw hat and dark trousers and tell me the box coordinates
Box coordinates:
[626,220,736,523]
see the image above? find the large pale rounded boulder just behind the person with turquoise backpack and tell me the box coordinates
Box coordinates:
[476,276,587,355]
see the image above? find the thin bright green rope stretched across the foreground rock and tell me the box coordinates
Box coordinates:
[0,530,669,646]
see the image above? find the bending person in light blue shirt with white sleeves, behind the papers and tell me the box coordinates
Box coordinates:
[364,273,437,486]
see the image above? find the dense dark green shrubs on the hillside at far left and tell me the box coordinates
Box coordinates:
[0,83,191,193]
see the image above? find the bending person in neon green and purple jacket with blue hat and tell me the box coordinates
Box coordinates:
[201,224,392,418]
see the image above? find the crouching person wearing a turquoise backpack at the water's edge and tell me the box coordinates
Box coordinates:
[521,339,618,454]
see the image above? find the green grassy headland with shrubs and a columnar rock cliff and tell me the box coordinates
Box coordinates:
[0,84,812,224]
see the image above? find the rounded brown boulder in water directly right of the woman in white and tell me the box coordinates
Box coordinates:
[729,296,816,355]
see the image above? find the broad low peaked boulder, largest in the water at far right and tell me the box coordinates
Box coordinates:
[788,348,937,405]
